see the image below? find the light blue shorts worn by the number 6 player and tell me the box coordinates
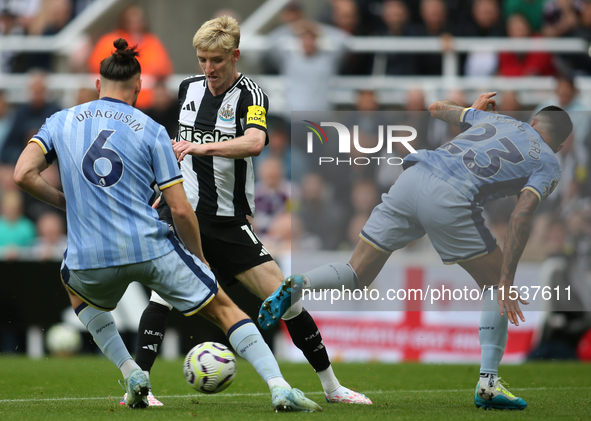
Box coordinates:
[62,234,218,316]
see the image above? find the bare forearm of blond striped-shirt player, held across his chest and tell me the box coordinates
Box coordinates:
[173,127,267,162]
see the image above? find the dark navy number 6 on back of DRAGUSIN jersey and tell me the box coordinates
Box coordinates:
[82,130,123,187]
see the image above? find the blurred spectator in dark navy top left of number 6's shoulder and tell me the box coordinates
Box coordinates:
[0,71,60,165]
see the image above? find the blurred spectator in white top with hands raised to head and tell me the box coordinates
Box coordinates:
[269,20,346,120]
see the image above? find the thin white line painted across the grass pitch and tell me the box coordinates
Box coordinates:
[0,386,591,403]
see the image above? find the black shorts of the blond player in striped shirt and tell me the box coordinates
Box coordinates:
[158,203,273,286]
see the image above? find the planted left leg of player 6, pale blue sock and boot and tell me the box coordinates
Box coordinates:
[62,266,150,409]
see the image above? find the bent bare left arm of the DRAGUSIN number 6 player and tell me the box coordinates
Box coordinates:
[14,142,66,212]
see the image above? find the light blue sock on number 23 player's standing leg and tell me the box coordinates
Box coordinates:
[478,286,509,374]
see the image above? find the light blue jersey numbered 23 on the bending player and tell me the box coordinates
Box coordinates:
[404,108,561,204]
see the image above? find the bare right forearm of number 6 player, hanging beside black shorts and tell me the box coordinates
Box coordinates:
[162,183,205,262]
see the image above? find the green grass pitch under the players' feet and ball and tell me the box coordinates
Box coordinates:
[0,356,591,421]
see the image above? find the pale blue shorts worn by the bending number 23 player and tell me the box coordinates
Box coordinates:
[360,163,497,264]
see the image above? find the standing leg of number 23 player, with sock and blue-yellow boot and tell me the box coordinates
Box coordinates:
[458,246,527,409]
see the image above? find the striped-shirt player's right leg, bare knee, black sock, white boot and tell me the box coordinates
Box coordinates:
[236,261,371,404]
